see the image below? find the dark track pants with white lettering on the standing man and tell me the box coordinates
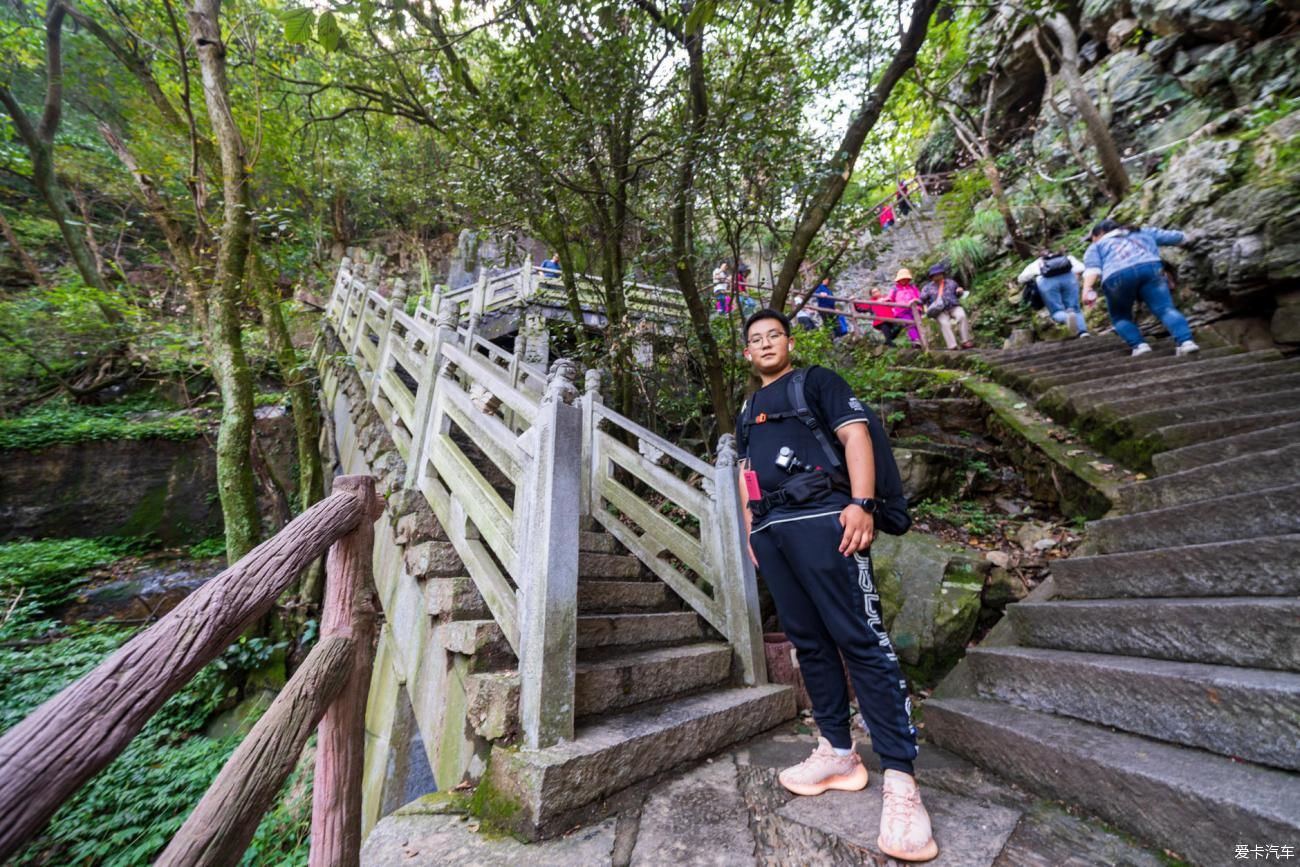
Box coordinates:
[749,511,917,773]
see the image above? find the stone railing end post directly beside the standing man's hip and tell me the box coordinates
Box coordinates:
[714,434,767,686]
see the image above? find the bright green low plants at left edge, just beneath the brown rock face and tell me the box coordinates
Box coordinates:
[0,537,147,608]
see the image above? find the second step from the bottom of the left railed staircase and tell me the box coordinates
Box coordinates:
[575,641,732,716]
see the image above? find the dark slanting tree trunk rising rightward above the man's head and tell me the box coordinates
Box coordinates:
[771,0,939,309]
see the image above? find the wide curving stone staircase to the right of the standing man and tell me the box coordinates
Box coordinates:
[924,335,1300,864]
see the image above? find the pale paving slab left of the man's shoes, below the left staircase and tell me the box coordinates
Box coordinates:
[631,757,754,867]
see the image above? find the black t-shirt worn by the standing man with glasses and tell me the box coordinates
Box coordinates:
[736,367,867,528]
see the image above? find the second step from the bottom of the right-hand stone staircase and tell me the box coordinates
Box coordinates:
[966,647,1300,770]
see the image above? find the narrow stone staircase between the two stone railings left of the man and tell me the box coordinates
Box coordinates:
[475,522,796,840]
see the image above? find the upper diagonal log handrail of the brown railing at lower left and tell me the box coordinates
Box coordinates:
[0,488,377,862]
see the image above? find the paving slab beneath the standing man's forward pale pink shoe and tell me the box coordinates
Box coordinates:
[776,785,1021,867]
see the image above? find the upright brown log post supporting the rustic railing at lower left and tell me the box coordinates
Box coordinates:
[308,476,384,867]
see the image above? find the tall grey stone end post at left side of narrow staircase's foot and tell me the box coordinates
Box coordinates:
[516,359,582,750]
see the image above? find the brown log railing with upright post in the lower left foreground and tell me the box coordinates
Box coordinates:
[0,476,382,866]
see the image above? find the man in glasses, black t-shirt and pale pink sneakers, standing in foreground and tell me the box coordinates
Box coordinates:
[736,309,939,861]
